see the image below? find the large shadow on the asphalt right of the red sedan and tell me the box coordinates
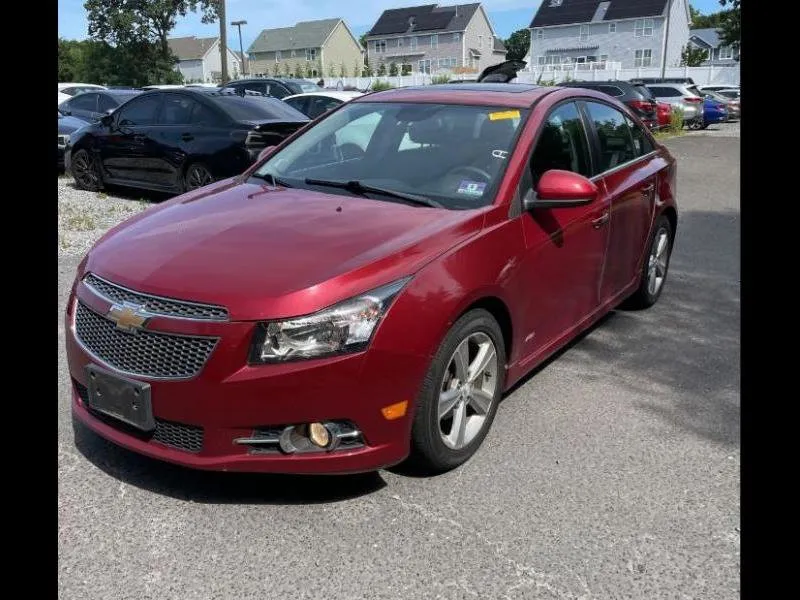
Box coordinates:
[500,211,741,448]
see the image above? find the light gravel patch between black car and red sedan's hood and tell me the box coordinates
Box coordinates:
[58,175,151,257]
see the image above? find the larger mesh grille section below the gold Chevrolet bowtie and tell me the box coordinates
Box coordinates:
[75,301,217,379]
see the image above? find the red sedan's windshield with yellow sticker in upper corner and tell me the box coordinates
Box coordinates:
[255,102,528,209]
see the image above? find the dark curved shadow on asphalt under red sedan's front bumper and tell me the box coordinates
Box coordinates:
[72,418,386,505]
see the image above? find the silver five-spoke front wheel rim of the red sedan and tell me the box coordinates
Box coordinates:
[438,332,498,450]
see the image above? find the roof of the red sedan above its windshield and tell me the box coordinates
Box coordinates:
[354,83,552,108]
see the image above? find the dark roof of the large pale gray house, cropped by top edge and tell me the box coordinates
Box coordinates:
[530,0,667,27]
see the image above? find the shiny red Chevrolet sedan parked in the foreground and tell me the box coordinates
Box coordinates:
[66,83,677,473]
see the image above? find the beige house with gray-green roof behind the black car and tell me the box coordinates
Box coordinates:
[247,19,364,78]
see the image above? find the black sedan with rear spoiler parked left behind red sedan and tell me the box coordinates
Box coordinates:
[66,88,309,193]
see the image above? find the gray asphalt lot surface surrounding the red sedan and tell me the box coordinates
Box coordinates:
[57,124,740,600]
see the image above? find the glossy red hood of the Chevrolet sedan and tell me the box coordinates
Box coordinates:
[84,180,484,320]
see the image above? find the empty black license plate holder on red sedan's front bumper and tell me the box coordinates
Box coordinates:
[86,365,156,432]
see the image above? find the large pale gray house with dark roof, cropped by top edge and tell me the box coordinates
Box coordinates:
[530,0,691,69]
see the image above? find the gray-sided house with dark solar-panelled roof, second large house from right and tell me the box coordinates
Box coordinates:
[366,3,506,73]
